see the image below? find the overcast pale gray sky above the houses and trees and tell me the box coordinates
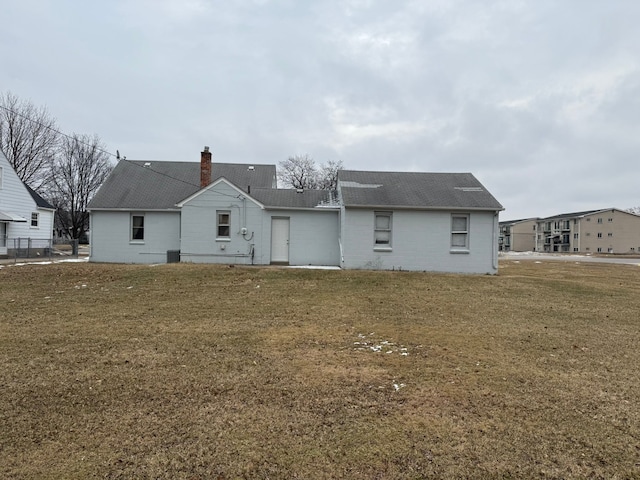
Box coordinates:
[0,0,640,219]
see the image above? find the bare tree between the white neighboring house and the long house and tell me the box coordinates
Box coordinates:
[50,134,113,239]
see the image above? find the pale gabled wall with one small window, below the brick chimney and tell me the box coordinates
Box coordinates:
[180,182,269,265]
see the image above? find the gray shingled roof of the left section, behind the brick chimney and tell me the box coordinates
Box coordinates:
[89,160,276,210]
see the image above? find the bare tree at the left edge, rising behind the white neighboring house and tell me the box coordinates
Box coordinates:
[0,92,60,191]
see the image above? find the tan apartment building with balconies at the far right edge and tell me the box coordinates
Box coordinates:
[536,208,640,253]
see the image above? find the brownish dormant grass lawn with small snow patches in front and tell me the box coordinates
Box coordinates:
[0,262,640,479]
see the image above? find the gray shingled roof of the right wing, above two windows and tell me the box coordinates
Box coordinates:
[338,170,503,210]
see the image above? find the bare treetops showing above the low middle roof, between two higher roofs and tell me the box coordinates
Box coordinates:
[278,154,342,190]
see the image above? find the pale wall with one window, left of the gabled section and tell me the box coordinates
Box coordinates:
[89,210,180,263]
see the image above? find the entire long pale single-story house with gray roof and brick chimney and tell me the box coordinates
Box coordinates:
[89,147,503,274]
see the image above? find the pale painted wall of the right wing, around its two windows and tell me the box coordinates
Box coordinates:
[342,208,498,274]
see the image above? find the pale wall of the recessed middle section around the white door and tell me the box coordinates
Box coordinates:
[262,208,340,266]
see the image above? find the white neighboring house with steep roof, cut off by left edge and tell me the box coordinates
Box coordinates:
[0,146,55,257]
